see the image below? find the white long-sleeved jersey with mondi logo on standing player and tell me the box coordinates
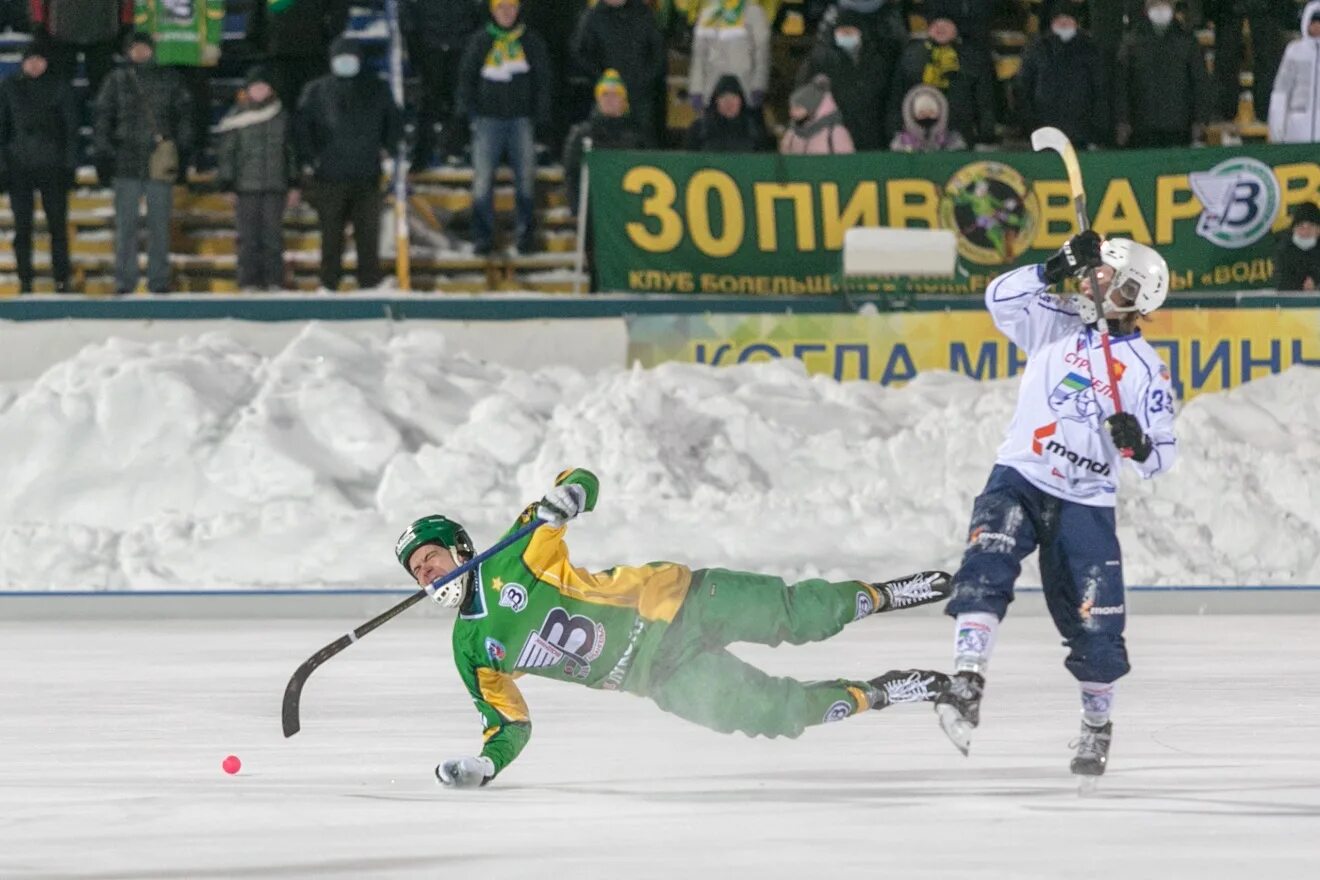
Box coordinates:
[986,265,1177,507]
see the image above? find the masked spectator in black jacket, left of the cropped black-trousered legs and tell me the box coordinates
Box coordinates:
[1114,0,1210,146]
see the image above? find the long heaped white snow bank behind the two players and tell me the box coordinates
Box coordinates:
[0,325,1320,590]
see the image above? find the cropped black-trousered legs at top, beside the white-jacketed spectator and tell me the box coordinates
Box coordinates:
[1214,0,1296,119]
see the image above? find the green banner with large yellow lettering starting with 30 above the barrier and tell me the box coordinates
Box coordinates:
[589,144,1320,294]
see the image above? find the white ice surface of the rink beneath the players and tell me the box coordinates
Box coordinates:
[0,615,1320,880]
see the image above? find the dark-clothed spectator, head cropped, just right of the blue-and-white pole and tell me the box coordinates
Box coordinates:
[399,0,482,168]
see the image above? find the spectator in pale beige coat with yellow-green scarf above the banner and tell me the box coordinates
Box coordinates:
[688,0,770,113]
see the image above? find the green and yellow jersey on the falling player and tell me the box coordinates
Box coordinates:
[454,468,692,773]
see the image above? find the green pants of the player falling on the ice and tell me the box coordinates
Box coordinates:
[643,569,876,736]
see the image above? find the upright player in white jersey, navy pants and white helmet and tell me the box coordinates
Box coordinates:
[936,231,1176,776]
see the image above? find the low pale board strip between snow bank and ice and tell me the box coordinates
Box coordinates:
[0,584,1320,621]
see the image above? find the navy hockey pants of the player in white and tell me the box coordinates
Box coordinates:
[945,466,1130,682]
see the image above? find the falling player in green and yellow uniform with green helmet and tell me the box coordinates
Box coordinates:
[395,468,949,788]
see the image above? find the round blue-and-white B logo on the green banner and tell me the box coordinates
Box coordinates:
[1188,156,1280,248]
